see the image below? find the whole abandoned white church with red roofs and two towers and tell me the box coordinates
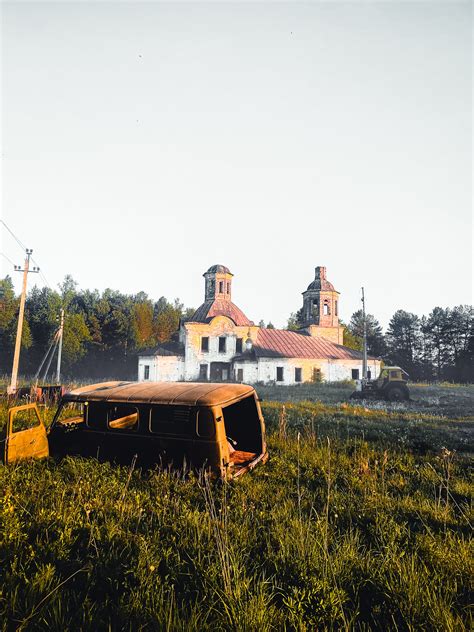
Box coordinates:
[138,265,380,384]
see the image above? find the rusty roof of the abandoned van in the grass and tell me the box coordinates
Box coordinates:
[63,382,254,406]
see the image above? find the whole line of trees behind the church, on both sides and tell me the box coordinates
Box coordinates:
[0,276,474,382]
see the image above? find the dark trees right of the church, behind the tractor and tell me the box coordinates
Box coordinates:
[288,305,474,383]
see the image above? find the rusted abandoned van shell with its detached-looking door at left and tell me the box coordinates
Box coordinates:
[5,382,268,478]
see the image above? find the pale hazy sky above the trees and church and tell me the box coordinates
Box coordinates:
[0,2,473,326]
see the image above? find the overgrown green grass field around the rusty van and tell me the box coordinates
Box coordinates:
[0,384,474,632]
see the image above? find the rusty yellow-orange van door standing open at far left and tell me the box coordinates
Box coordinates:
[5,404,49,463]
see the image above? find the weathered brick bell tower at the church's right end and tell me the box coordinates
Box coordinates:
[302,266,343,344]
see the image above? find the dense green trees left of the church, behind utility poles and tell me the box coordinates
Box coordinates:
[0,276,194,379]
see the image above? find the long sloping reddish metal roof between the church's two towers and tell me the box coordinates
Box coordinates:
[253,329,362,360]
